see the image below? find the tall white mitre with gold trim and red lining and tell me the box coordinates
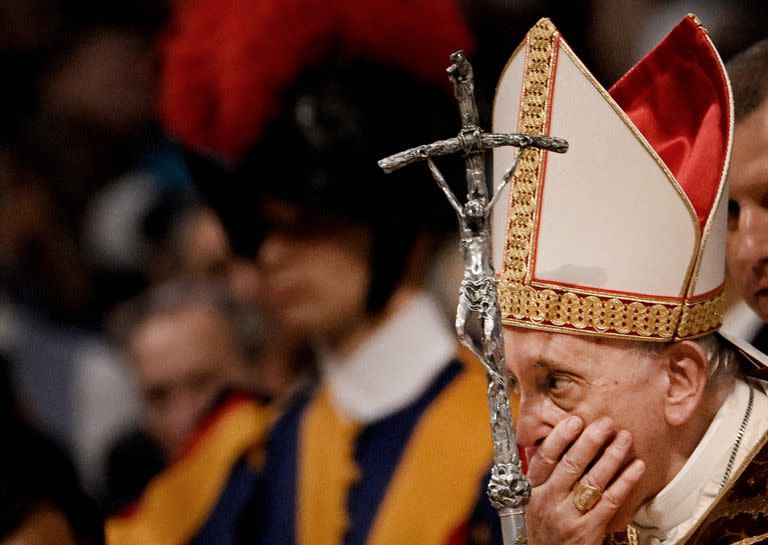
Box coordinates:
[492,15,733,341]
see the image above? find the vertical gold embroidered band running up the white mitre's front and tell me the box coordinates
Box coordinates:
[502,19,556,282]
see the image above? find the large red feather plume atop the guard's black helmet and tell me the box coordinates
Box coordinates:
[160,0,473,161]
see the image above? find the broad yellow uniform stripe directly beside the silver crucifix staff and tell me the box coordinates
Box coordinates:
[368,356,493,545]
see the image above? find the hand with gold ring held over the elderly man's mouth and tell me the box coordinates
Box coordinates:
[526,416,645,545]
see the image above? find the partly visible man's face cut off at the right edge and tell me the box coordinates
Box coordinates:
[728,101,768,320]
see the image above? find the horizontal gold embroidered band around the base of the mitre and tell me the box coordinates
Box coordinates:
[498,279,723,341]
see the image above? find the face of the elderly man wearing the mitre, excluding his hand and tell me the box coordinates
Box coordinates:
[504,327,668,528]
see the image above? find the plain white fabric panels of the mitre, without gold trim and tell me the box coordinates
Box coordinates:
[492,33,704,297]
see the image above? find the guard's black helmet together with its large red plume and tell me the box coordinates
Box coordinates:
[160,0,472,311]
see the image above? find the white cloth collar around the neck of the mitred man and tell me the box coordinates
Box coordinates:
[633,380,768,545]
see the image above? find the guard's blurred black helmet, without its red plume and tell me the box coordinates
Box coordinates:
[188,56,464,311]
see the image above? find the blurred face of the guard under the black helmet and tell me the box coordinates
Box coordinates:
[246,201,372,342]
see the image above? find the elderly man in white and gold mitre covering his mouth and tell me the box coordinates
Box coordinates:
[493,11,768,545]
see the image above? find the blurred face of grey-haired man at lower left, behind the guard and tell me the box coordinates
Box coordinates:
[130,305,247,457]
